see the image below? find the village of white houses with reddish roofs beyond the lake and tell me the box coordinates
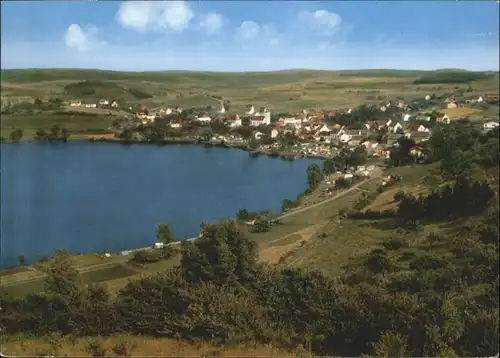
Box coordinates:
[69,94,499,159]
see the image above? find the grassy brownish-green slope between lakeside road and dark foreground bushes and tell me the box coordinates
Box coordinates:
[255,165,441,277]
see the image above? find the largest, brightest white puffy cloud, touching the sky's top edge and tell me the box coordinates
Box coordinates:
[117,1,194,32]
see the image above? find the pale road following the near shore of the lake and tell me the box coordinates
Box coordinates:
[1,168,382,287]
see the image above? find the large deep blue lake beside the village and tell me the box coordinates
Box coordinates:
[0,142,321,268]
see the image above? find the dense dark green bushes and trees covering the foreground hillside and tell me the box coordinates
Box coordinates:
[0,201,498,357]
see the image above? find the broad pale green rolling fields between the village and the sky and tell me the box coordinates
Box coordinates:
[2,70,498,113]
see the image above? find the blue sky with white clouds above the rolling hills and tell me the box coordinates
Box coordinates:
[1,0,500,71]
